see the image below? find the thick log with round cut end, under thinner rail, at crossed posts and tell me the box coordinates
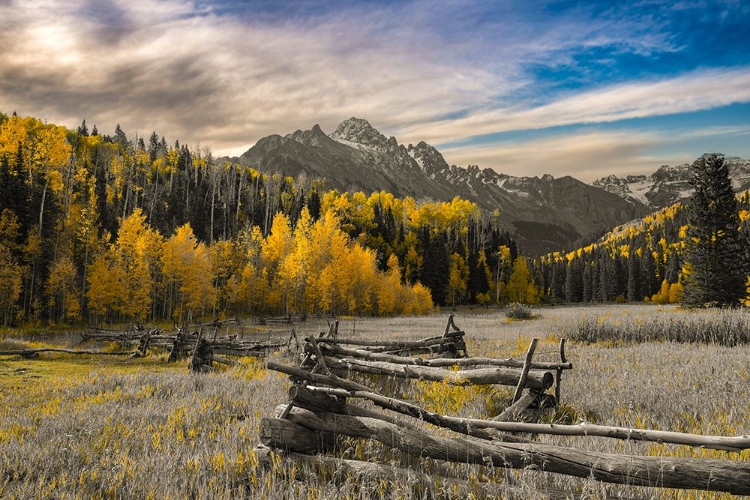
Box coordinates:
[325,356,554,390]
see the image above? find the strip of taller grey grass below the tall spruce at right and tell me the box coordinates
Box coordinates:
[564,309,750,347]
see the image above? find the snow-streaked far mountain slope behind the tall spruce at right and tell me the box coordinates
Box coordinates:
[592,157,750,210]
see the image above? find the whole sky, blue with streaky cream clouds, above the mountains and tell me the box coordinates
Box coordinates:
[0,0,750,182]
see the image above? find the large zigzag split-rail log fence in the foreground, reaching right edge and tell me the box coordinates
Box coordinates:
[259,317,750,495]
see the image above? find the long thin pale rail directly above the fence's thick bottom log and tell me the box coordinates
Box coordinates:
[294,386,750,453]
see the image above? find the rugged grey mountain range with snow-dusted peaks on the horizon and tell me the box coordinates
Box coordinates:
[234,118,750,255]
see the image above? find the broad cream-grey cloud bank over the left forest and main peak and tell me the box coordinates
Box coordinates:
[0,0,502,149]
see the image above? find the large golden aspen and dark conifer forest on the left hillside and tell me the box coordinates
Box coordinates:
[0,113,541,325]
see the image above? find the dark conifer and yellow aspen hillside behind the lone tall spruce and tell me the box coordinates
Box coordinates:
[532,192,750,304]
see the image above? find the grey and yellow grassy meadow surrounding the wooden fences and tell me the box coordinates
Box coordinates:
[0,305,750,499]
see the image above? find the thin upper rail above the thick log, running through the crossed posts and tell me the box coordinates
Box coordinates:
[318,342,573,370]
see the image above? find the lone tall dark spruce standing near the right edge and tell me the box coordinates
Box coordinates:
[684,154,747,307]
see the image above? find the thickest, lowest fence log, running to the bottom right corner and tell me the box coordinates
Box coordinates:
[282,408,750,495]
